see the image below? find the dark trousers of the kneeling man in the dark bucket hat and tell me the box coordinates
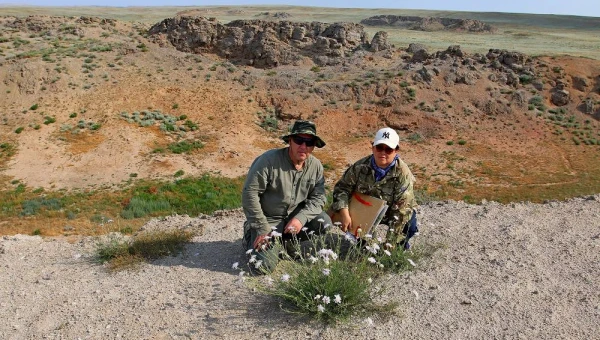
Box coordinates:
[242,212,332,273]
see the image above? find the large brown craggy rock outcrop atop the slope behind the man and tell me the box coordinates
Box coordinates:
[149,16,376,68]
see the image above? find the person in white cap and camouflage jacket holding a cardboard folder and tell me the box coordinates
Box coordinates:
[331,127,418,249]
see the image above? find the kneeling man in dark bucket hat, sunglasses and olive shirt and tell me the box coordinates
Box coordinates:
[242,120,331,272]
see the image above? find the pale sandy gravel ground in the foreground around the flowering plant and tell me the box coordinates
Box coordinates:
[0,195,600,340]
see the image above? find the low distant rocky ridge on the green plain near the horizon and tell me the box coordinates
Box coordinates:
[360,15,496,33]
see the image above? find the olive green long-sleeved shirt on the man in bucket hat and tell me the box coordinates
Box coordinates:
[242,147,327,235]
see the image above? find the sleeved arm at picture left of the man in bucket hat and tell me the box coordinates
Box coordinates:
[242,159,271,235]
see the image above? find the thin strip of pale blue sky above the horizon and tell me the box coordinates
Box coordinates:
[0,0,600,17]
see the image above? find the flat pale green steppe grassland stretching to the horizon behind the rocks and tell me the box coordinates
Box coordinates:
[2,6,600,59]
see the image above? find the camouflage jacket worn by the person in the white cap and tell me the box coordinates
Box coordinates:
[331,155,417,243]
